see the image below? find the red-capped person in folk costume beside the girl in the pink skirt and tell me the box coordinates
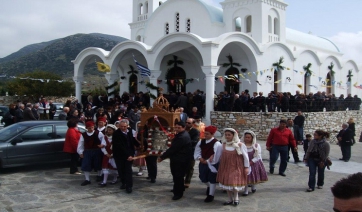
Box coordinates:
[194,126,222,202]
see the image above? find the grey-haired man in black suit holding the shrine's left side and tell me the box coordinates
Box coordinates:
[112,119,139,193]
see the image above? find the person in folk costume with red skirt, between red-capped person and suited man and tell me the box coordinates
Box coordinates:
[99,124,118,187]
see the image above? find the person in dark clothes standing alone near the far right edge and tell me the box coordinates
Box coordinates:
[337,123,353,162]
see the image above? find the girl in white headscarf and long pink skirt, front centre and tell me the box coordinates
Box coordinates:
[216,128,250,206]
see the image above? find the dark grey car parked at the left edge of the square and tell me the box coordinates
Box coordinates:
[0,121,86,168]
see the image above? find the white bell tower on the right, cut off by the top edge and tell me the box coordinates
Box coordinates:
[220,0,288,44]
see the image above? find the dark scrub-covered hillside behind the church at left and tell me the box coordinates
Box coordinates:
[0,33,126,77]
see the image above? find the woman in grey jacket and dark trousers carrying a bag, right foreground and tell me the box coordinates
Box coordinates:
[304,130,330,192]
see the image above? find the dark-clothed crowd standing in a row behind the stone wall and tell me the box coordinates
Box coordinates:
[215,90,361,112]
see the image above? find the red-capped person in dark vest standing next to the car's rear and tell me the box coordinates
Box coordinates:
[77,121,104,186]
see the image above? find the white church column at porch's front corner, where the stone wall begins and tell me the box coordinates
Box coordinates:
[201,66,220,125]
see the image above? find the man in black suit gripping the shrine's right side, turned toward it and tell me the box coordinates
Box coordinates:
[158,122,192,200]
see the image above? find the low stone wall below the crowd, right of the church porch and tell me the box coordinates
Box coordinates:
[211,111,362,141]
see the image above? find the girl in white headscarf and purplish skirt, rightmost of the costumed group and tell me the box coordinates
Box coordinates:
[241,130,268,196]
